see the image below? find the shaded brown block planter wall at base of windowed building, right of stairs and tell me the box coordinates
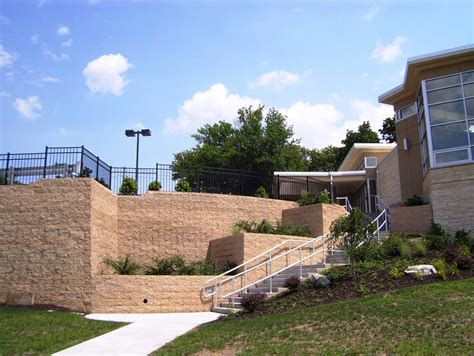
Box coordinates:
[390,204,433,234]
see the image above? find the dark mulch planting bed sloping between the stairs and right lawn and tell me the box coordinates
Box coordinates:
[226,256,474,320]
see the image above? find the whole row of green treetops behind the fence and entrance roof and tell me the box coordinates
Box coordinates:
[173,106,388,179]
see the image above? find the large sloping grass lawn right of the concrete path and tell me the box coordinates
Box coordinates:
[156,278,474,355]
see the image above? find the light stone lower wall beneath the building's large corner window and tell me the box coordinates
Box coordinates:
[426,163,474,233]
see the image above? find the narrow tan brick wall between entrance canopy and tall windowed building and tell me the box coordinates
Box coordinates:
[377,148,402,206]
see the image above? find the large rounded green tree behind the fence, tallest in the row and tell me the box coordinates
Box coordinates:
[173,106,308,179]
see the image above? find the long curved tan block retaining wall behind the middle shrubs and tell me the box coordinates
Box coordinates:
[118,192,297,263]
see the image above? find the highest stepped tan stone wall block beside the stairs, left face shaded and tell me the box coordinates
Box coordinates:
[282,204,346,237]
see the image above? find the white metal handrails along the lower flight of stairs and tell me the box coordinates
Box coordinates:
[203,235,326,301]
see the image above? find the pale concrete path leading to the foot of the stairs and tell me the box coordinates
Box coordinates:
[55,312,221,355]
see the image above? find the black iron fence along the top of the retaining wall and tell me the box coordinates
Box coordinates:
[0,147,273,196]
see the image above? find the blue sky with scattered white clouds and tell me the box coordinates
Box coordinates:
[0,0,474,166]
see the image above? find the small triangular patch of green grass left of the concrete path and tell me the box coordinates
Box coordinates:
[0,306,126,355]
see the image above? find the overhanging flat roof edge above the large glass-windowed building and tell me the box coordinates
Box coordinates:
[378,44,474,105]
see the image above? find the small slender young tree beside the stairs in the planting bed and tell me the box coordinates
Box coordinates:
[330,208,375,281]
